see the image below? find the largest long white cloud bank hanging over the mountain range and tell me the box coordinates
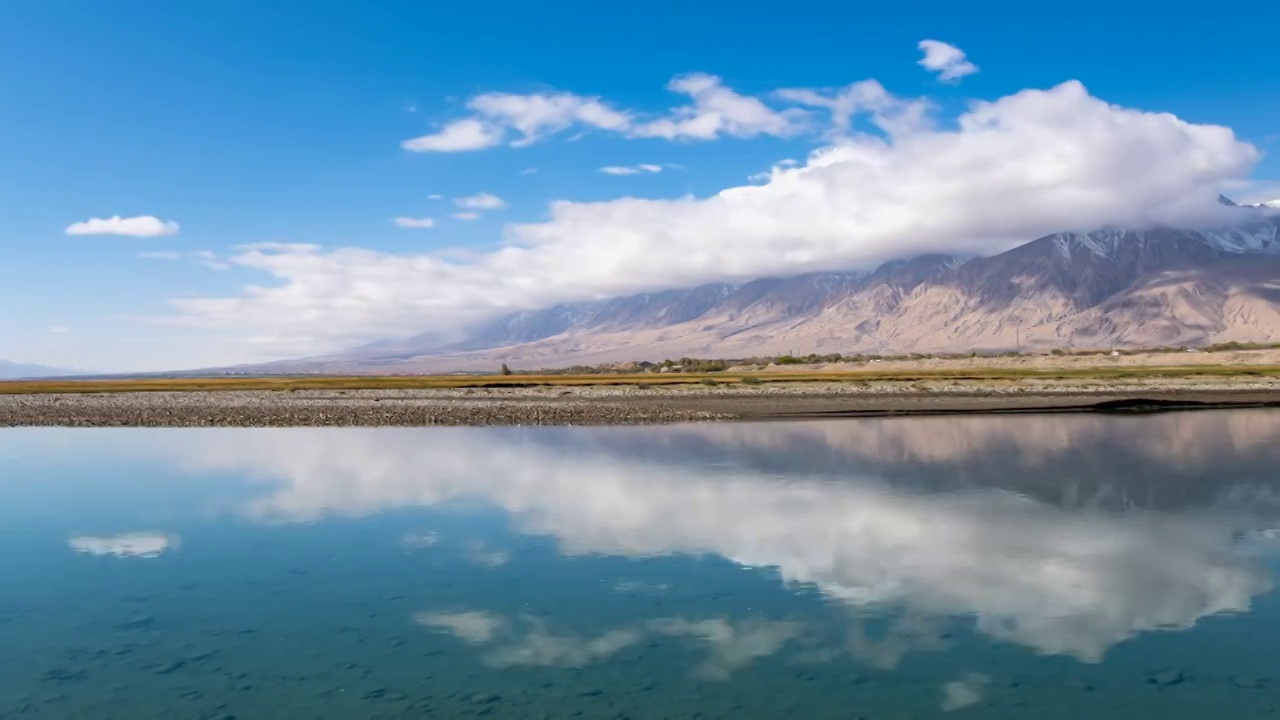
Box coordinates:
[170,78,1260,352]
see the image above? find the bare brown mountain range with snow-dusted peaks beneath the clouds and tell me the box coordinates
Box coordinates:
[259,199,1280,373]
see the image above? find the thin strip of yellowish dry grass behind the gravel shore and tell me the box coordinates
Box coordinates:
[0,365,1280,395]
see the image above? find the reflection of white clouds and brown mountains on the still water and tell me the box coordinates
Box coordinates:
[178,411,1280,661]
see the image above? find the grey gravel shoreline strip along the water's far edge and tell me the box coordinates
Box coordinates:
[0,377,1280,427]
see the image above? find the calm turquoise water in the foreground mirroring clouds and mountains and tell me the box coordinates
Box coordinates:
[0,411,1280,720]
